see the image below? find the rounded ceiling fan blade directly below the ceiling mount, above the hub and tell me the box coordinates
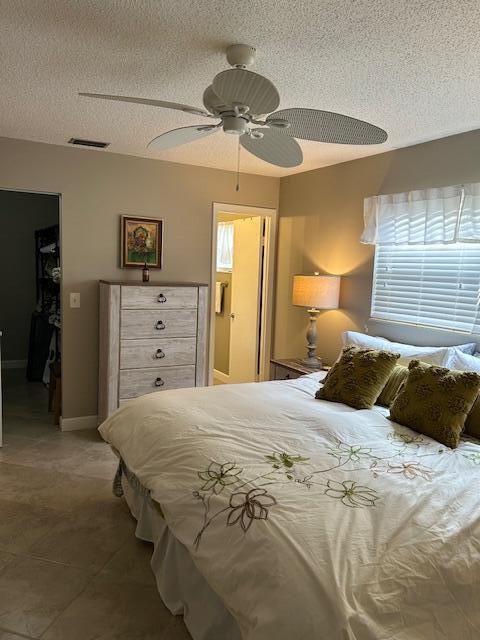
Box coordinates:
[212,69,280,115]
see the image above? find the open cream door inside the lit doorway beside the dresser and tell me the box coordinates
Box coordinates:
[229,216,263,383]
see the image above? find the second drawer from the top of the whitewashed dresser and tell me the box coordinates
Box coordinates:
[120,309,197,340]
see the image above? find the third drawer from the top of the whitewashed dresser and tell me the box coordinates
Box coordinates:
[120,338,196,369]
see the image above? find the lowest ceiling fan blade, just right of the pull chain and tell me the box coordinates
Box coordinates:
[240,129,303,167]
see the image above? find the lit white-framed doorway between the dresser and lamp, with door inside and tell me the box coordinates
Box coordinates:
[210,204,276,384]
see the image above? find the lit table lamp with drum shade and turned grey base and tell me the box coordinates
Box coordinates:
[292,273,340,369]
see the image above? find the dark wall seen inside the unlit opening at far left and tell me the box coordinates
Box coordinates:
[0,190,59,362]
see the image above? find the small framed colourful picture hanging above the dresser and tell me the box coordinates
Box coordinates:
[120,216,163,269]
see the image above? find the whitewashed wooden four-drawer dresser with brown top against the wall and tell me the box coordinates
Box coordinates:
[98,280,208,422]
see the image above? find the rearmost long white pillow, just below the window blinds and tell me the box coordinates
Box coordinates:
[343,331,476,366]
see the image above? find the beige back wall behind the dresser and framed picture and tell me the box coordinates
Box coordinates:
[0,138,279,418]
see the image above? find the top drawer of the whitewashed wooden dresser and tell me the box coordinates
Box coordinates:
[122,286,198,310]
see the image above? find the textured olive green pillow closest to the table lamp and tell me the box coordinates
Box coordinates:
[315,346,400,409]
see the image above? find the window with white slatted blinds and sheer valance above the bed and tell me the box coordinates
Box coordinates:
[361,183,480,333]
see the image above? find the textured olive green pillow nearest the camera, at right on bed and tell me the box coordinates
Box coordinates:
[390,360,480,449]
